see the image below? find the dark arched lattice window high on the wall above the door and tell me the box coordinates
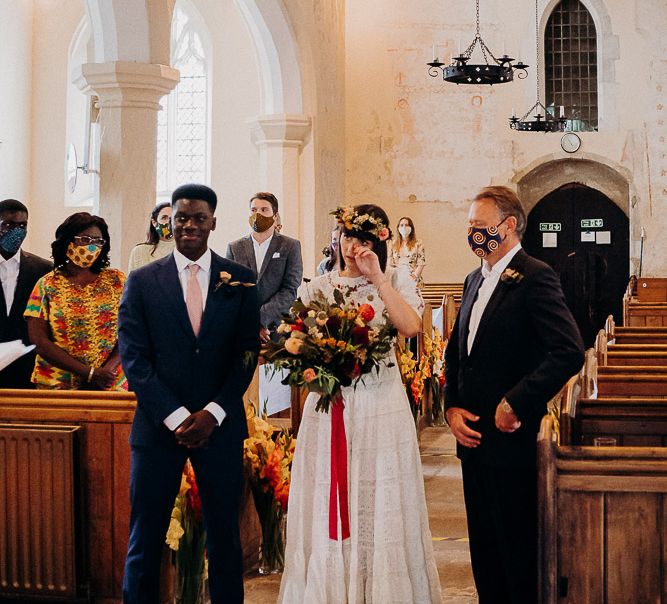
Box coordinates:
[544,0,598,130]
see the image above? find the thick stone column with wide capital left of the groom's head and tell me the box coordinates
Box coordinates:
[75,61,179,271]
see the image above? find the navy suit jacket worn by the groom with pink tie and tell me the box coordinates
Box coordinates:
[118,253,259,445]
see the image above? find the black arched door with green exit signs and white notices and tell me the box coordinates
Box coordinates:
[523,183,630,347]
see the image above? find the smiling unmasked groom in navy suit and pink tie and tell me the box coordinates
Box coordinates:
[118,185,259,604]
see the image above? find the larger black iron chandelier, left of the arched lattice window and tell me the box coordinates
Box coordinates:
[427,0,528,86]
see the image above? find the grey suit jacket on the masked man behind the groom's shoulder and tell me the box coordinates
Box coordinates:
[225,233,303,330]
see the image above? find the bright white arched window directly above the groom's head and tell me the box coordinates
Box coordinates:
[157,2,209,199]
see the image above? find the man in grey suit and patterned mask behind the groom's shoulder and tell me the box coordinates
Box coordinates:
[225,193,303,342]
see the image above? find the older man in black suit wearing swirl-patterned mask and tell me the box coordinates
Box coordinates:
[445,187,583,604]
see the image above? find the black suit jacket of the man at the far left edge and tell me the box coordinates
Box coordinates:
[0,250,53,388]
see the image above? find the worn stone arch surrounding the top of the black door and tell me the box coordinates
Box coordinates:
[512,153,632,216]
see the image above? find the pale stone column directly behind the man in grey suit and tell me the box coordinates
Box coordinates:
[251,114,314,242]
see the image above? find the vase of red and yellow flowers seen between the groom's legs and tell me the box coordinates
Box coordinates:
[166,460,207,604]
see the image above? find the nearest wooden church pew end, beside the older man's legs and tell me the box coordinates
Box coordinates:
[538,416,667,604]
